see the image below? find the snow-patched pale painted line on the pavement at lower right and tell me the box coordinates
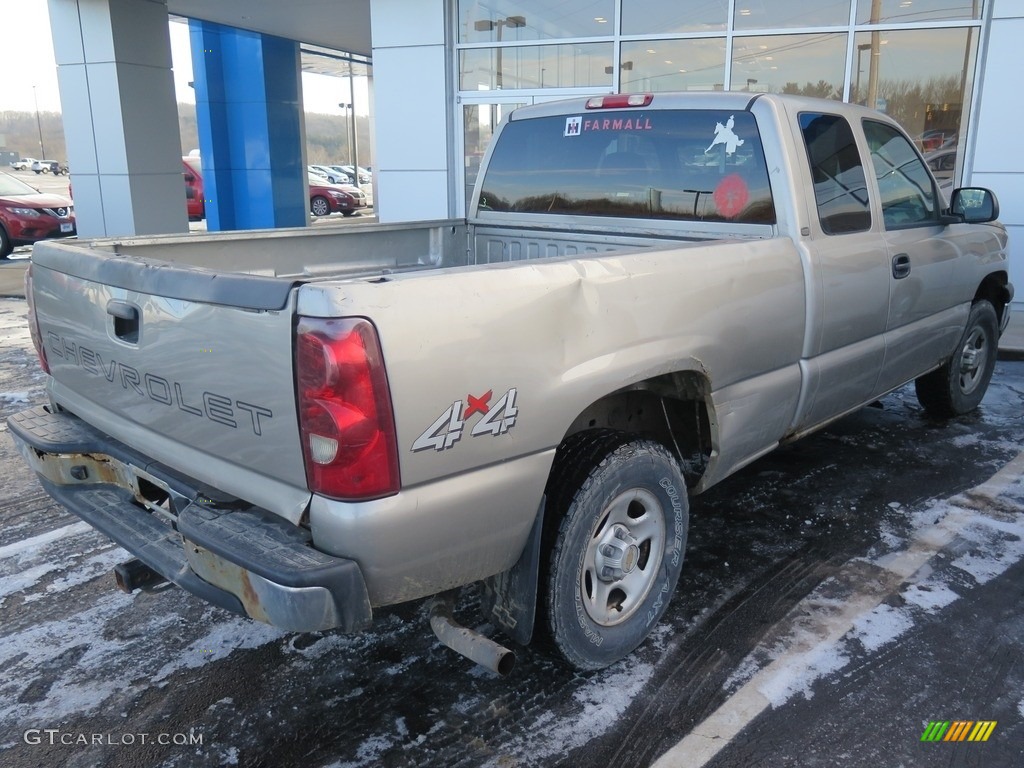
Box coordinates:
[654,466,1024,768]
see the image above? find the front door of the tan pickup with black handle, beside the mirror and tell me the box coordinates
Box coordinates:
[863,120,973,394]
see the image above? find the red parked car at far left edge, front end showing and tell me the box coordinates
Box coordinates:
[0,173,76,259]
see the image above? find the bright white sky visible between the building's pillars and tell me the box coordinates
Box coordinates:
[0,0,369,115]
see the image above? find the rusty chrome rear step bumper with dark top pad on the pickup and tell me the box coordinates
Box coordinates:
[7,407,373,632]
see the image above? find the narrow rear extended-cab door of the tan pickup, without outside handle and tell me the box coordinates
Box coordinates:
[793,112,890,434]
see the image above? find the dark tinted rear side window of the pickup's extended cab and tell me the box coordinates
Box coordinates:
[800,112,871,234]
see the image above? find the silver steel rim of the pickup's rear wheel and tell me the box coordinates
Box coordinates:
[580,488,666,627]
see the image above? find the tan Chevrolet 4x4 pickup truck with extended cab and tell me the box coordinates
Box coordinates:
[9,93,1013,672]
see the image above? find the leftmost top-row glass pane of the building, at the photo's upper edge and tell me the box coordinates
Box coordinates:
[459,0,615,43]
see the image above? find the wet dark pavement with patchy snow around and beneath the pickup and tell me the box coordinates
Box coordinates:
[0,299,1024,768]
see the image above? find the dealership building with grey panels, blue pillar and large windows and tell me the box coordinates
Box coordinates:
[48,0,1024,300]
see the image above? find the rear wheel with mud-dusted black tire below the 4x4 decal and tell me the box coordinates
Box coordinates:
[538,430,689,670]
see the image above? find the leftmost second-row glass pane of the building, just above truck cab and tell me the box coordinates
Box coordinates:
[459,43,612,91]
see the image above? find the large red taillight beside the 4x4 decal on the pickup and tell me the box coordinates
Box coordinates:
[295,317,400,501]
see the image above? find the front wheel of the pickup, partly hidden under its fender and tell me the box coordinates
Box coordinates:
[914,301,999,419]
